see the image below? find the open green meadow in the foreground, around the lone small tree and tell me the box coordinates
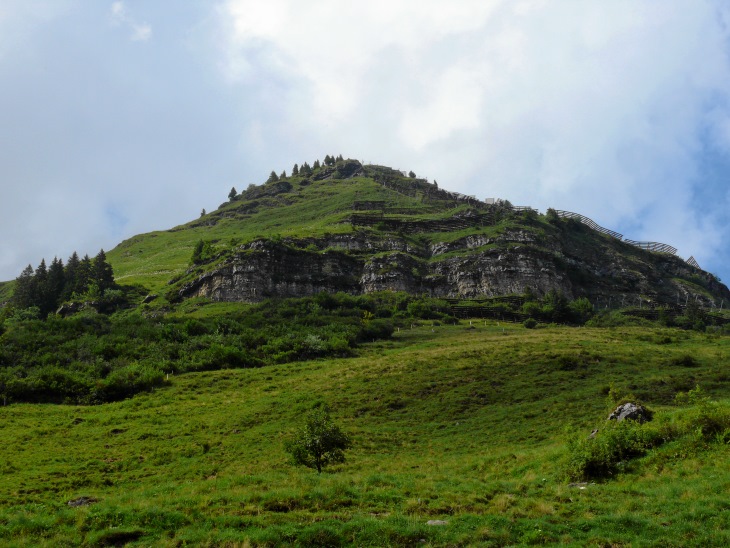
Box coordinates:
[0,321,730,546]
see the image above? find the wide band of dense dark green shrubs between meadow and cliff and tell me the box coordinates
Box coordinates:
[0,294,456,403]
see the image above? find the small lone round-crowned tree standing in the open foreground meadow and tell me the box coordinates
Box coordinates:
[286,407,352,473]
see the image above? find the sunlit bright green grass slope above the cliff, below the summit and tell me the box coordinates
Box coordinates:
[107,177,426,292]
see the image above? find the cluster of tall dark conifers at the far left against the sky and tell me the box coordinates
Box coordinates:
[12,249,116,317]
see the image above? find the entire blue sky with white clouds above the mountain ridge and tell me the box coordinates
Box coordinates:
[0,0,730,282]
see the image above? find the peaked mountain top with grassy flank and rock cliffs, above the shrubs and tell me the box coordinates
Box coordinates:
[108,160,730,309]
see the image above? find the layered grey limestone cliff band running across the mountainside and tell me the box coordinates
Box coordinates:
[179,230,730,306]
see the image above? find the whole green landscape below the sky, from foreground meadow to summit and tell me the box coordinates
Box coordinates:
[0,156,730,547]
